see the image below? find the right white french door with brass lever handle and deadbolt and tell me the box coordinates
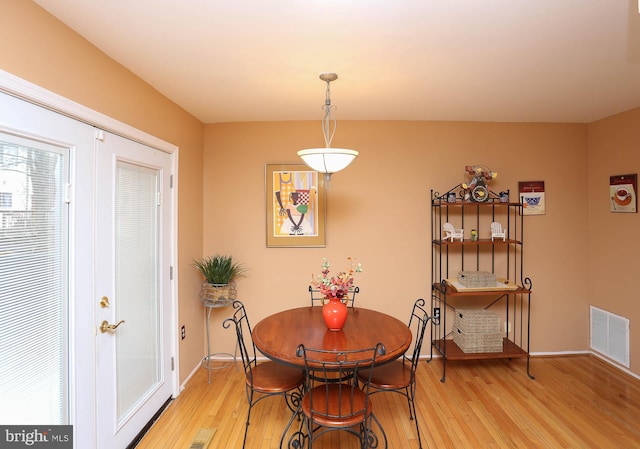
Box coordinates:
[95,132,173,449]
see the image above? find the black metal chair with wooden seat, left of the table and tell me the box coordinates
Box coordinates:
[222,301,305,448]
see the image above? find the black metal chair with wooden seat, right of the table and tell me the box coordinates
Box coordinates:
[358,299,431,448]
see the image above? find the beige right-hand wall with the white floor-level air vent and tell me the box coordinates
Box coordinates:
[583,108,640,374]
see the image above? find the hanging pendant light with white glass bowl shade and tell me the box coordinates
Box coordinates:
[298,73,358,188]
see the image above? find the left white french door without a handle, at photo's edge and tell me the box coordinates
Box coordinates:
[0,93,96,440]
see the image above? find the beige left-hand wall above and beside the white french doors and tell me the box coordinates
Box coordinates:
[0,0,204,381]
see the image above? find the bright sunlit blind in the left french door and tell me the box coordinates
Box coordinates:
[0,133,68,425]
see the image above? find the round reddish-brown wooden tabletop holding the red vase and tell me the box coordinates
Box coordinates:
[252,306,411,368]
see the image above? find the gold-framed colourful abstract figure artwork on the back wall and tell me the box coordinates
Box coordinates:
[265,164,326,247]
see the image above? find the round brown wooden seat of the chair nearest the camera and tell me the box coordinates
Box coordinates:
[301,384,372,427]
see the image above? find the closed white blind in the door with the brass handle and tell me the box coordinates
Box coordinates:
[115,161,160,420]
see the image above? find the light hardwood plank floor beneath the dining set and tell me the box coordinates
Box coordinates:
[137,355,640,449]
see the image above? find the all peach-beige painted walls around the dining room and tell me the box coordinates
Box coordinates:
[0,0,640,380]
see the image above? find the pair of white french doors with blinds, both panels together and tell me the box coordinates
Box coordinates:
[0,83,178,449]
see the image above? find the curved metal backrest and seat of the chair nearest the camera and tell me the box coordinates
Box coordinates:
[297,343,386,427]
